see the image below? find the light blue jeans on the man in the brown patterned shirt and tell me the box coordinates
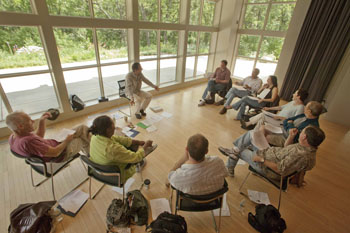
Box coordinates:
[226,131,263,173]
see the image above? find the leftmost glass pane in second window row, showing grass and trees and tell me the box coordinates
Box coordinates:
[0,26,48,74]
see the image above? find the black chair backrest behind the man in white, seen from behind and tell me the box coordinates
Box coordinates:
[176,180,228,211]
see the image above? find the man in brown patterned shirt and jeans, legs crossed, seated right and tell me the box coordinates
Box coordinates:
[219,125,325,180]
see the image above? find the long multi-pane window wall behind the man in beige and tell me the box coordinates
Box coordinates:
[0,0,219,124]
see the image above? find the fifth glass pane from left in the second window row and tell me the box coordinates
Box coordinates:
[160,31,179,57]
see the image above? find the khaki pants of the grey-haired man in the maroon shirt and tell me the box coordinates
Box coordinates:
[62,125,90,162]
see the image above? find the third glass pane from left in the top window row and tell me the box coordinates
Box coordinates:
[92,0,126,19]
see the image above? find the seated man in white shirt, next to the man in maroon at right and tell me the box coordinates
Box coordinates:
[224,68,262,107]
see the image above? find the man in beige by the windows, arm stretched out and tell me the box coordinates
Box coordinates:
[125,62,159,119]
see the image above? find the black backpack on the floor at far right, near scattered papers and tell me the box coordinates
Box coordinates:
[248,204,287,233]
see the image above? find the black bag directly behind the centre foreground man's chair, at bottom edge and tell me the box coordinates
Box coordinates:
[146,212,187,233]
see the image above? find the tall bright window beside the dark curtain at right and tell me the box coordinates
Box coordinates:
[233,0,295,80]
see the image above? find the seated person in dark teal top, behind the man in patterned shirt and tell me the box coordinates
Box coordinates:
[265,101,323,146]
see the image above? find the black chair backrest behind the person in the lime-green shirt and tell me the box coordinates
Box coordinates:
[80,155,122,187]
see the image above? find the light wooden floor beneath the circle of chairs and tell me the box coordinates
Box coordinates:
[0,85,350,233]
